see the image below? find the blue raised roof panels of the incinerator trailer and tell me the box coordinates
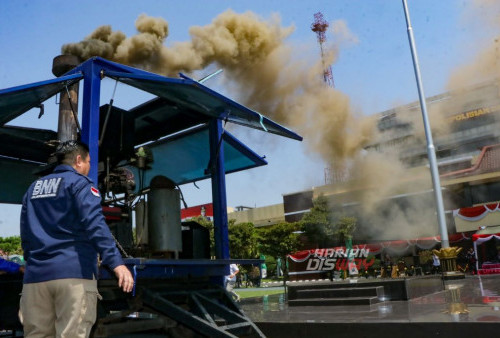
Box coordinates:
[0,57,302,203]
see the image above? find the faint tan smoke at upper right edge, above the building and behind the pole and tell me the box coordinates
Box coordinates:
[376,0,500,151]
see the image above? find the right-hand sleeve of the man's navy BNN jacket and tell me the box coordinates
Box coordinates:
[75,181,123,269]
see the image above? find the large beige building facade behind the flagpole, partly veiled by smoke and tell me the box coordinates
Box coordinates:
[236,82,500,242]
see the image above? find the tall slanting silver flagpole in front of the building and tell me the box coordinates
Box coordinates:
[403,0,450,248]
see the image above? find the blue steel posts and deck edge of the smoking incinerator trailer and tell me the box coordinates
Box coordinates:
[63,58,262,285]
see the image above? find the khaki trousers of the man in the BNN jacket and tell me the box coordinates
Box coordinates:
[19,278,100,338]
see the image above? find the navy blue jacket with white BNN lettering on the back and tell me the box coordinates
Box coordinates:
[21,165,123,283]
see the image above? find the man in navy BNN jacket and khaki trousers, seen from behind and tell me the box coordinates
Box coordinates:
[20,141,134,337]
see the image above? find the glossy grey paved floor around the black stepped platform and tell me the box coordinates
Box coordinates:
[241,275,500,324]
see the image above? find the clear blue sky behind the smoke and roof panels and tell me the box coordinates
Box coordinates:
[0,0,498,236]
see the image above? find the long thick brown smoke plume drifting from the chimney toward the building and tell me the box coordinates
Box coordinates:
[62,10,458,239]
